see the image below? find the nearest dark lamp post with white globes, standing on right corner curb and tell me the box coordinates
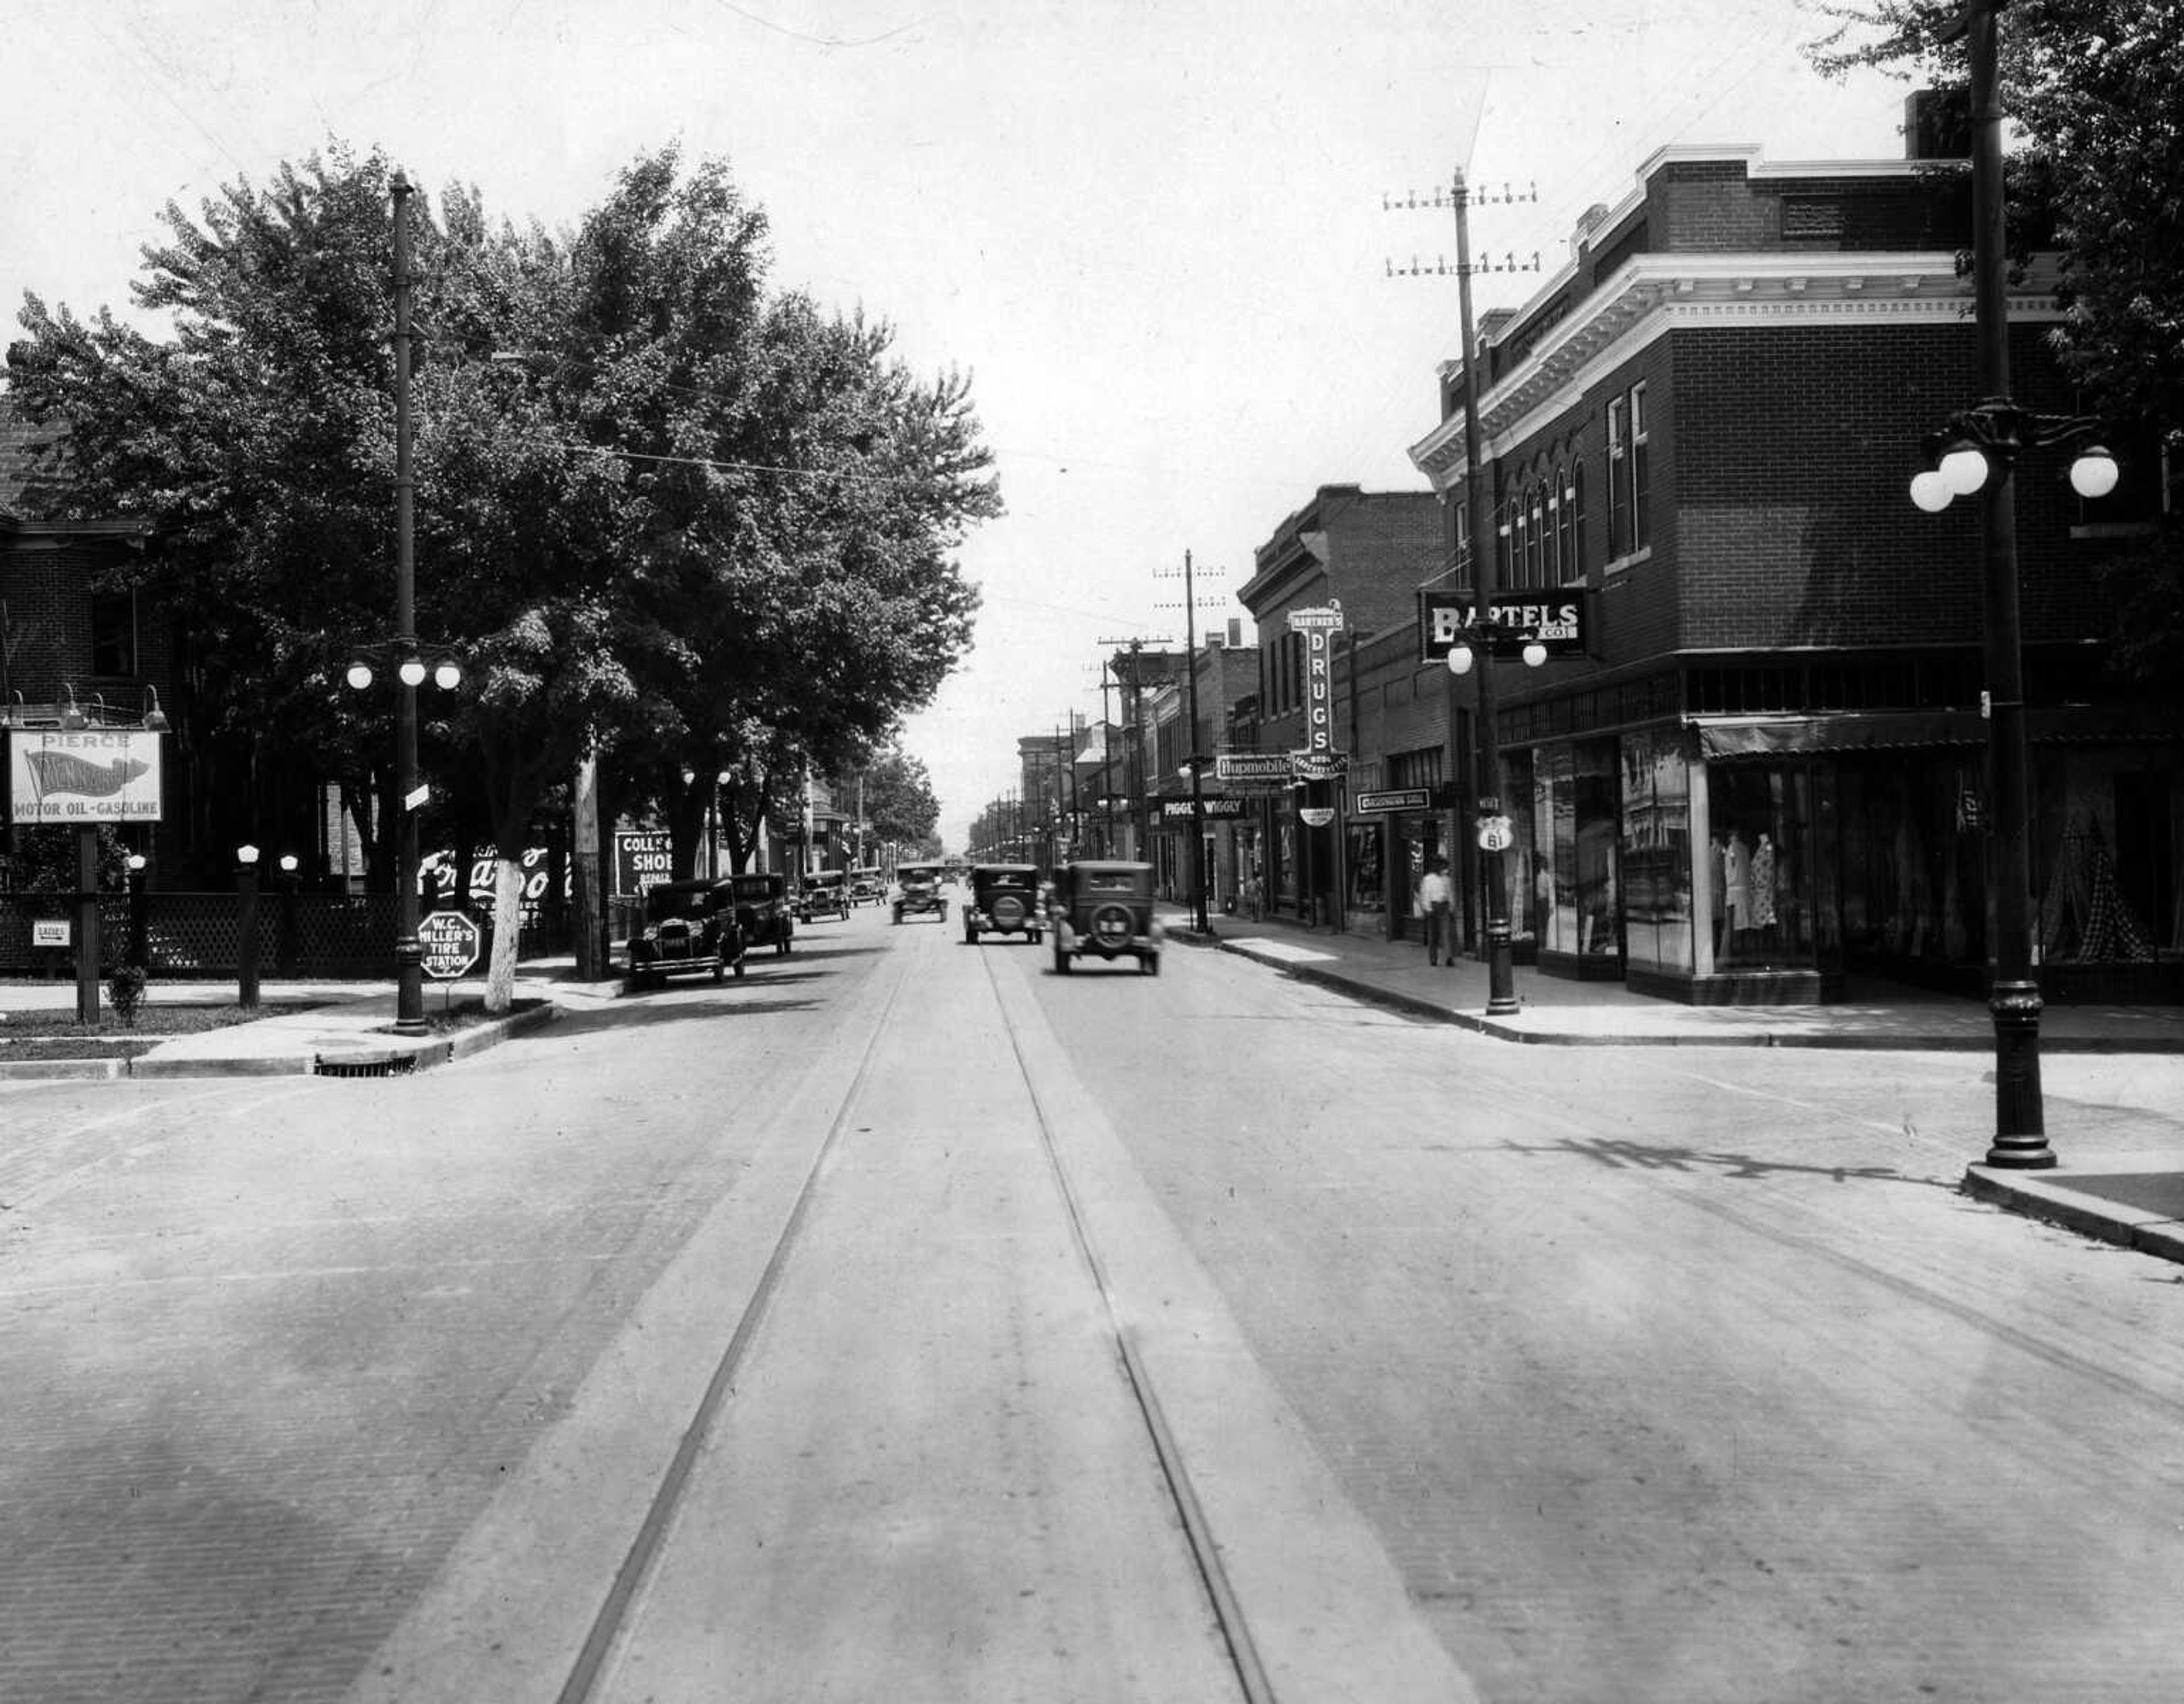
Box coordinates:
[1911,0,2116,1171]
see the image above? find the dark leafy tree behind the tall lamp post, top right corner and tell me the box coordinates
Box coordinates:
[1809,0,2184,681]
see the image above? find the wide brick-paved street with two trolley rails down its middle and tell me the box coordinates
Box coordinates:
[0,911,2184,1704]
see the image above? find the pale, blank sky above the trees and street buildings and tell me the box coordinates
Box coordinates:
[0,0,1906,850]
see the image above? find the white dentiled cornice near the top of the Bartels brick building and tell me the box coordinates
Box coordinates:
[1409,251,2062,491]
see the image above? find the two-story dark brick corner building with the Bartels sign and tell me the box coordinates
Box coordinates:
[1396,148,2184,1000]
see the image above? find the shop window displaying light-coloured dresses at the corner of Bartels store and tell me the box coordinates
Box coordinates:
[1706,763,1813,970]
